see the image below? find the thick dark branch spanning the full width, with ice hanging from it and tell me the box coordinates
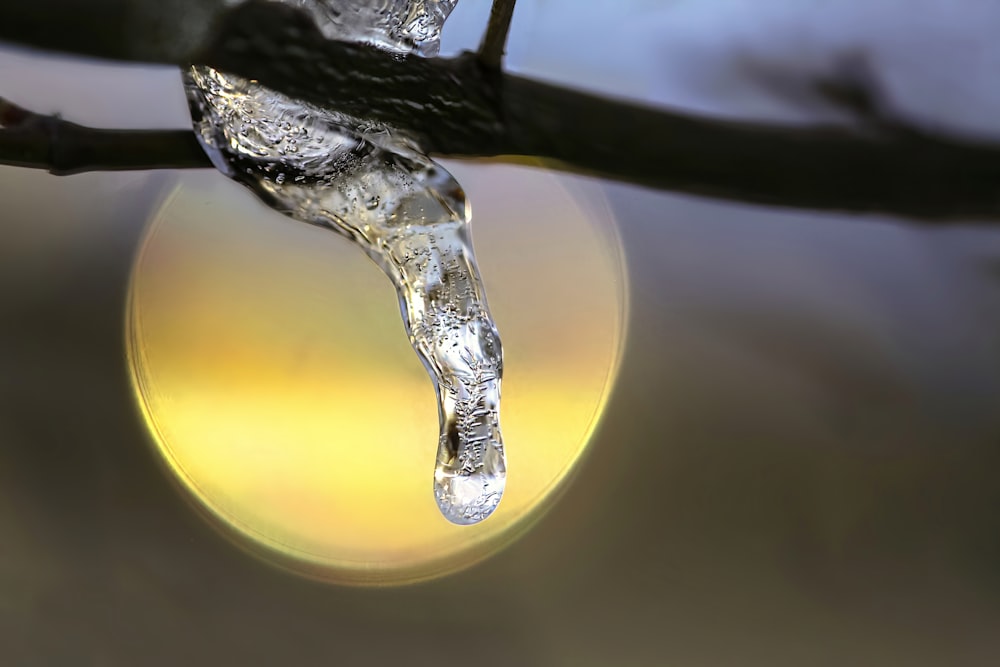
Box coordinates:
[0,0,1000,220]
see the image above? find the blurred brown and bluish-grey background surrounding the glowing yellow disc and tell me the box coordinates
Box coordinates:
[0,0,1000,666]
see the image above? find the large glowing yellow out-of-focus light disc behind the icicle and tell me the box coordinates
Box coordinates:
[127,164,626,584]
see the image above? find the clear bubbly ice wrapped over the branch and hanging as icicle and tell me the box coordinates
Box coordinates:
[185,0,507,524]
